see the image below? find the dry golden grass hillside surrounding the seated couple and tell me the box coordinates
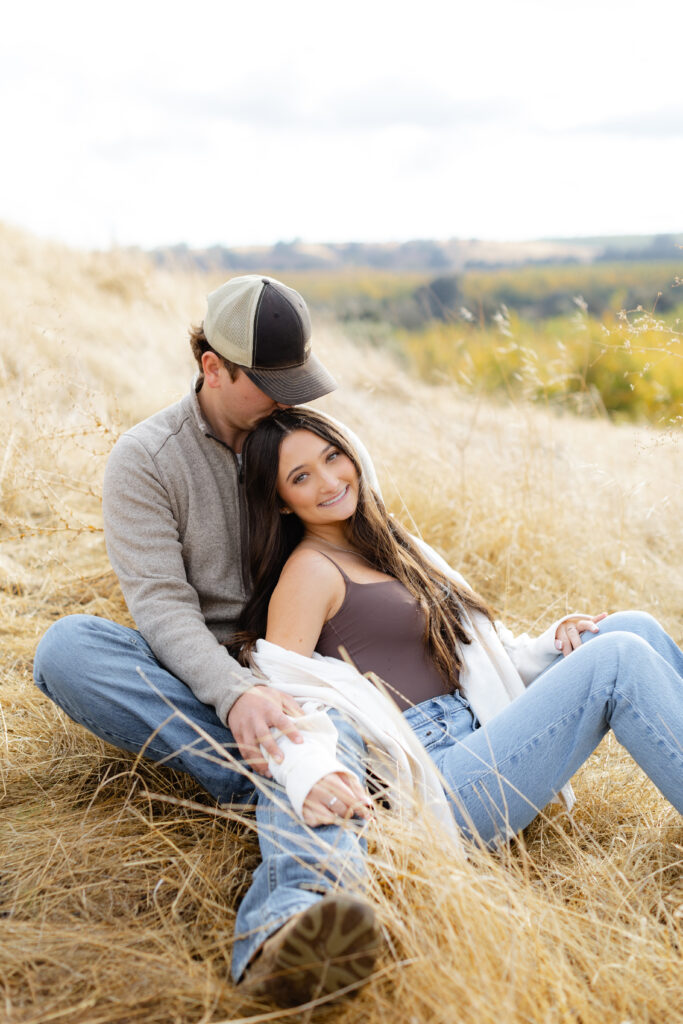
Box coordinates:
[0,228,683,1024]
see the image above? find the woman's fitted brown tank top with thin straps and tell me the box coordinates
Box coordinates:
[315,552,447,711]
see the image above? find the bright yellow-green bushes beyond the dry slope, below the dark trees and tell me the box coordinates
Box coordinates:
[399,309,683,425]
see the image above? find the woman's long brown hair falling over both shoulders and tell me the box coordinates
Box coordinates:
[231,409,492,689]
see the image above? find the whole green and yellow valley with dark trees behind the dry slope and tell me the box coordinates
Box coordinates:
[280,262,683,425]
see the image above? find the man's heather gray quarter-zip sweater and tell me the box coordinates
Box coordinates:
[102,386,377,722]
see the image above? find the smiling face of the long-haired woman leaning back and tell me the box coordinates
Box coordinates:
[278,430,358,526]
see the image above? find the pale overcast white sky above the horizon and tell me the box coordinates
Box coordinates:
[0,0,683,248]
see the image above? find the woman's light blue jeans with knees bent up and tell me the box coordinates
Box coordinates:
[404,611,683,844]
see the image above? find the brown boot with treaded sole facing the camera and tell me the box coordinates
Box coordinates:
[239,893,381,1007]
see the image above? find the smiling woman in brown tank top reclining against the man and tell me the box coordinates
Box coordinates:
[231,410,683,1003]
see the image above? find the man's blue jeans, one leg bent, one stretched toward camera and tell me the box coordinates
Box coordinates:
[34,615,365,981]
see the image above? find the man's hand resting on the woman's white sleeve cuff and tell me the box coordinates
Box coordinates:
[227,686,303,778]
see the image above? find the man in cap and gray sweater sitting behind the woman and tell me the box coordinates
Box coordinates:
[34,275,377,1004]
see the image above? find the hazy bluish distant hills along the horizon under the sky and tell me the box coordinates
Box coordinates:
[151,233,683,273]
